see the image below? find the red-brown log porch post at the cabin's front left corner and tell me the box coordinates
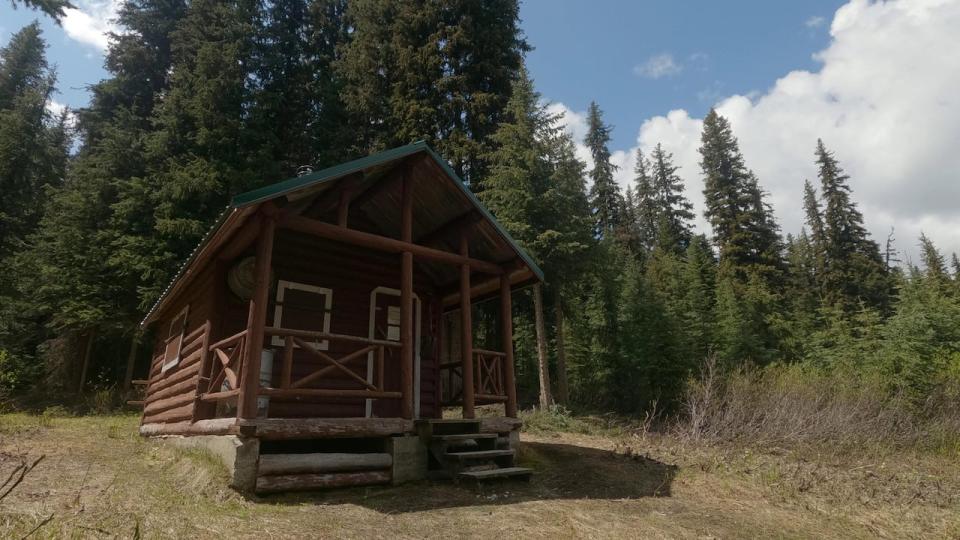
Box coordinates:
[237,209,276,419]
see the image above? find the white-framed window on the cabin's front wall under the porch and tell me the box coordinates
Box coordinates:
[272,279,333,350]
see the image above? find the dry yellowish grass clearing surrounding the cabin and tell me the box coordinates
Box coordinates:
[0,410,960,538]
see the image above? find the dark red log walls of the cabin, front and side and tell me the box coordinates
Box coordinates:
[143,229,441,423]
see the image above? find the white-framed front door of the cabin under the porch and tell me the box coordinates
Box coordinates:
[366,287,420,418]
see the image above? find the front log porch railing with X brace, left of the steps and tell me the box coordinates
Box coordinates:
[258,327,403,399]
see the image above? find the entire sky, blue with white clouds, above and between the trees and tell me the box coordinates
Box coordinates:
[0,0,960,262]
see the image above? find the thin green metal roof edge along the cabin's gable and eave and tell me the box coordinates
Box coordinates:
[140,141,543,325]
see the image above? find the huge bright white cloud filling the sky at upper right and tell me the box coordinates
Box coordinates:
[596,0,960,261]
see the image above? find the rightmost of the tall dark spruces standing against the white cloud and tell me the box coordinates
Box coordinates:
[816,140,890,311]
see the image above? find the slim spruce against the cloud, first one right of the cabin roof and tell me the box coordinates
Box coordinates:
[583,102,624,238]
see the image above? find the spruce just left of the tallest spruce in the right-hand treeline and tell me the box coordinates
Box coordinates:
[650,143,693,254]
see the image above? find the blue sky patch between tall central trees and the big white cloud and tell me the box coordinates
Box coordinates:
[520,0,843,147]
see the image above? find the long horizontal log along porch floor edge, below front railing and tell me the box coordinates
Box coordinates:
[239,418,413,440]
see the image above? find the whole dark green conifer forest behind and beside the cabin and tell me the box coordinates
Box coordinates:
[0,0,960,412]
